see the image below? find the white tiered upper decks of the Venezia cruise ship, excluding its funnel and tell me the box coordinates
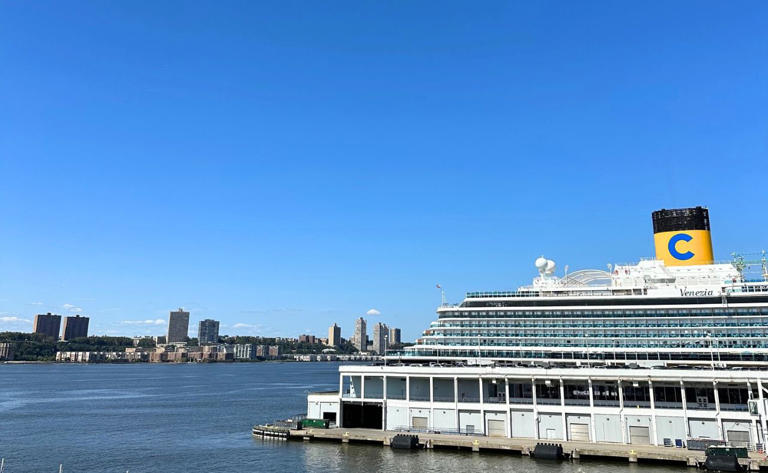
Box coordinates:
[401,254,768,366]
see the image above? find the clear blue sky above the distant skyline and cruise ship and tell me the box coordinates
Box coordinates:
[0,0,768,339]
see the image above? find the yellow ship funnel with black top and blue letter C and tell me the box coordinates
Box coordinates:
[651,207,714,266]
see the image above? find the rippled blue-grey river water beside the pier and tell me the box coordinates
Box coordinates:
[0,363,683,473]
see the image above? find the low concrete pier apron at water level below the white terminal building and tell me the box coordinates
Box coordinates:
[280,428,768,471]
